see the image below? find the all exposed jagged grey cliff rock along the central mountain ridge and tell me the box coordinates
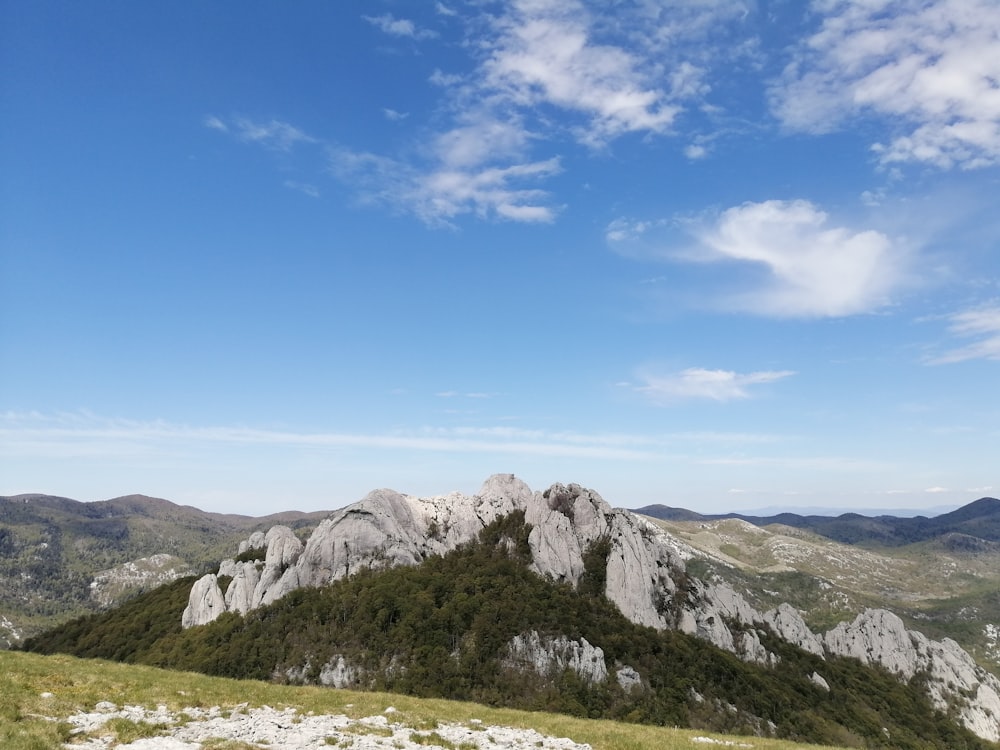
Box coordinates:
[183,474,1000,741]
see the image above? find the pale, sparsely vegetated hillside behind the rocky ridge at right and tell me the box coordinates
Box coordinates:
[640,516,1000,674]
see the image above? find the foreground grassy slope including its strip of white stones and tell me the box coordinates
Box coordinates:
[0,651,856,750]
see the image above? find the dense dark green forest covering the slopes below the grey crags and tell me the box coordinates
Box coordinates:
[26,514,989,750]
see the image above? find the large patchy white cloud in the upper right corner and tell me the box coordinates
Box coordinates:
[771,0,1000,168]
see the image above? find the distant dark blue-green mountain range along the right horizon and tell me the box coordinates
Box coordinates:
[633,497,1000,547]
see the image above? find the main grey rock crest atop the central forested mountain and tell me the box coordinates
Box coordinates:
[184,474,683,640]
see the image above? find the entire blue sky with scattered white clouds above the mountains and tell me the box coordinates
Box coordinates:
[0,0,1000,515]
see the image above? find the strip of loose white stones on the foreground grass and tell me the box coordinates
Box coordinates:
[64,702,590,750]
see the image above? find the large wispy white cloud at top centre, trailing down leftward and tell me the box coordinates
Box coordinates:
[324,0,745,226]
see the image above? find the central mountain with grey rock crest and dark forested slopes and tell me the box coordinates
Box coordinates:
[26,475,1000,748]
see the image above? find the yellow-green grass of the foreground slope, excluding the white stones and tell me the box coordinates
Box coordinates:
[0,651,848,750]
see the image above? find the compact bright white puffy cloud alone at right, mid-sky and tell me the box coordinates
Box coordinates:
[698,200,904,317]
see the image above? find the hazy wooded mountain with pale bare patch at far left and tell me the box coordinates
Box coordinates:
[0,494,326,646]
